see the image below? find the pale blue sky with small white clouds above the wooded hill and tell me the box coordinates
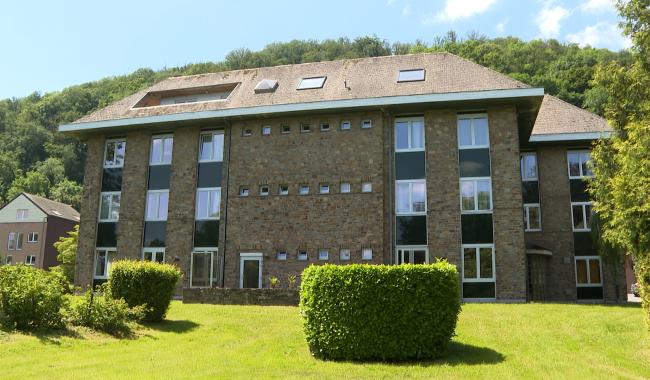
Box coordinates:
[0,0,630,99]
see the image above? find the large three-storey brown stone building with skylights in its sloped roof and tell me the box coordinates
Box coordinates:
[60,53,624,301]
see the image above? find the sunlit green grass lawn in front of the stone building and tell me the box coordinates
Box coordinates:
[0,302,650,379]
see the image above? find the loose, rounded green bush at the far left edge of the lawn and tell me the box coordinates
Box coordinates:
[0,265,66,330]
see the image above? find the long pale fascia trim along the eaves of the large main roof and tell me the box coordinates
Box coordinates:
[59,88,544,132]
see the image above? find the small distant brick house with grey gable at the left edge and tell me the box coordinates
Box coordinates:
[0,193,79,269]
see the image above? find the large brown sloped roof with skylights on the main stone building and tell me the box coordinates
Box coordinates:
[75,53,530,123]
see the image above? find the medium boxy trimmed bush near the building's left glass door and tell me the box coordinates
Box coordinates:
[108,260,181,322]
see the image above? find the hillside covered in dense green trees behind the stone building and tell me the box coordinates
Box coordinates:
[0,32,631,208]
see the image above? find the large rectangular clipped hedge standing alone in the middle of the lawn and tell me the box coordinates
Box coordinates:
[300,261,460,361]
